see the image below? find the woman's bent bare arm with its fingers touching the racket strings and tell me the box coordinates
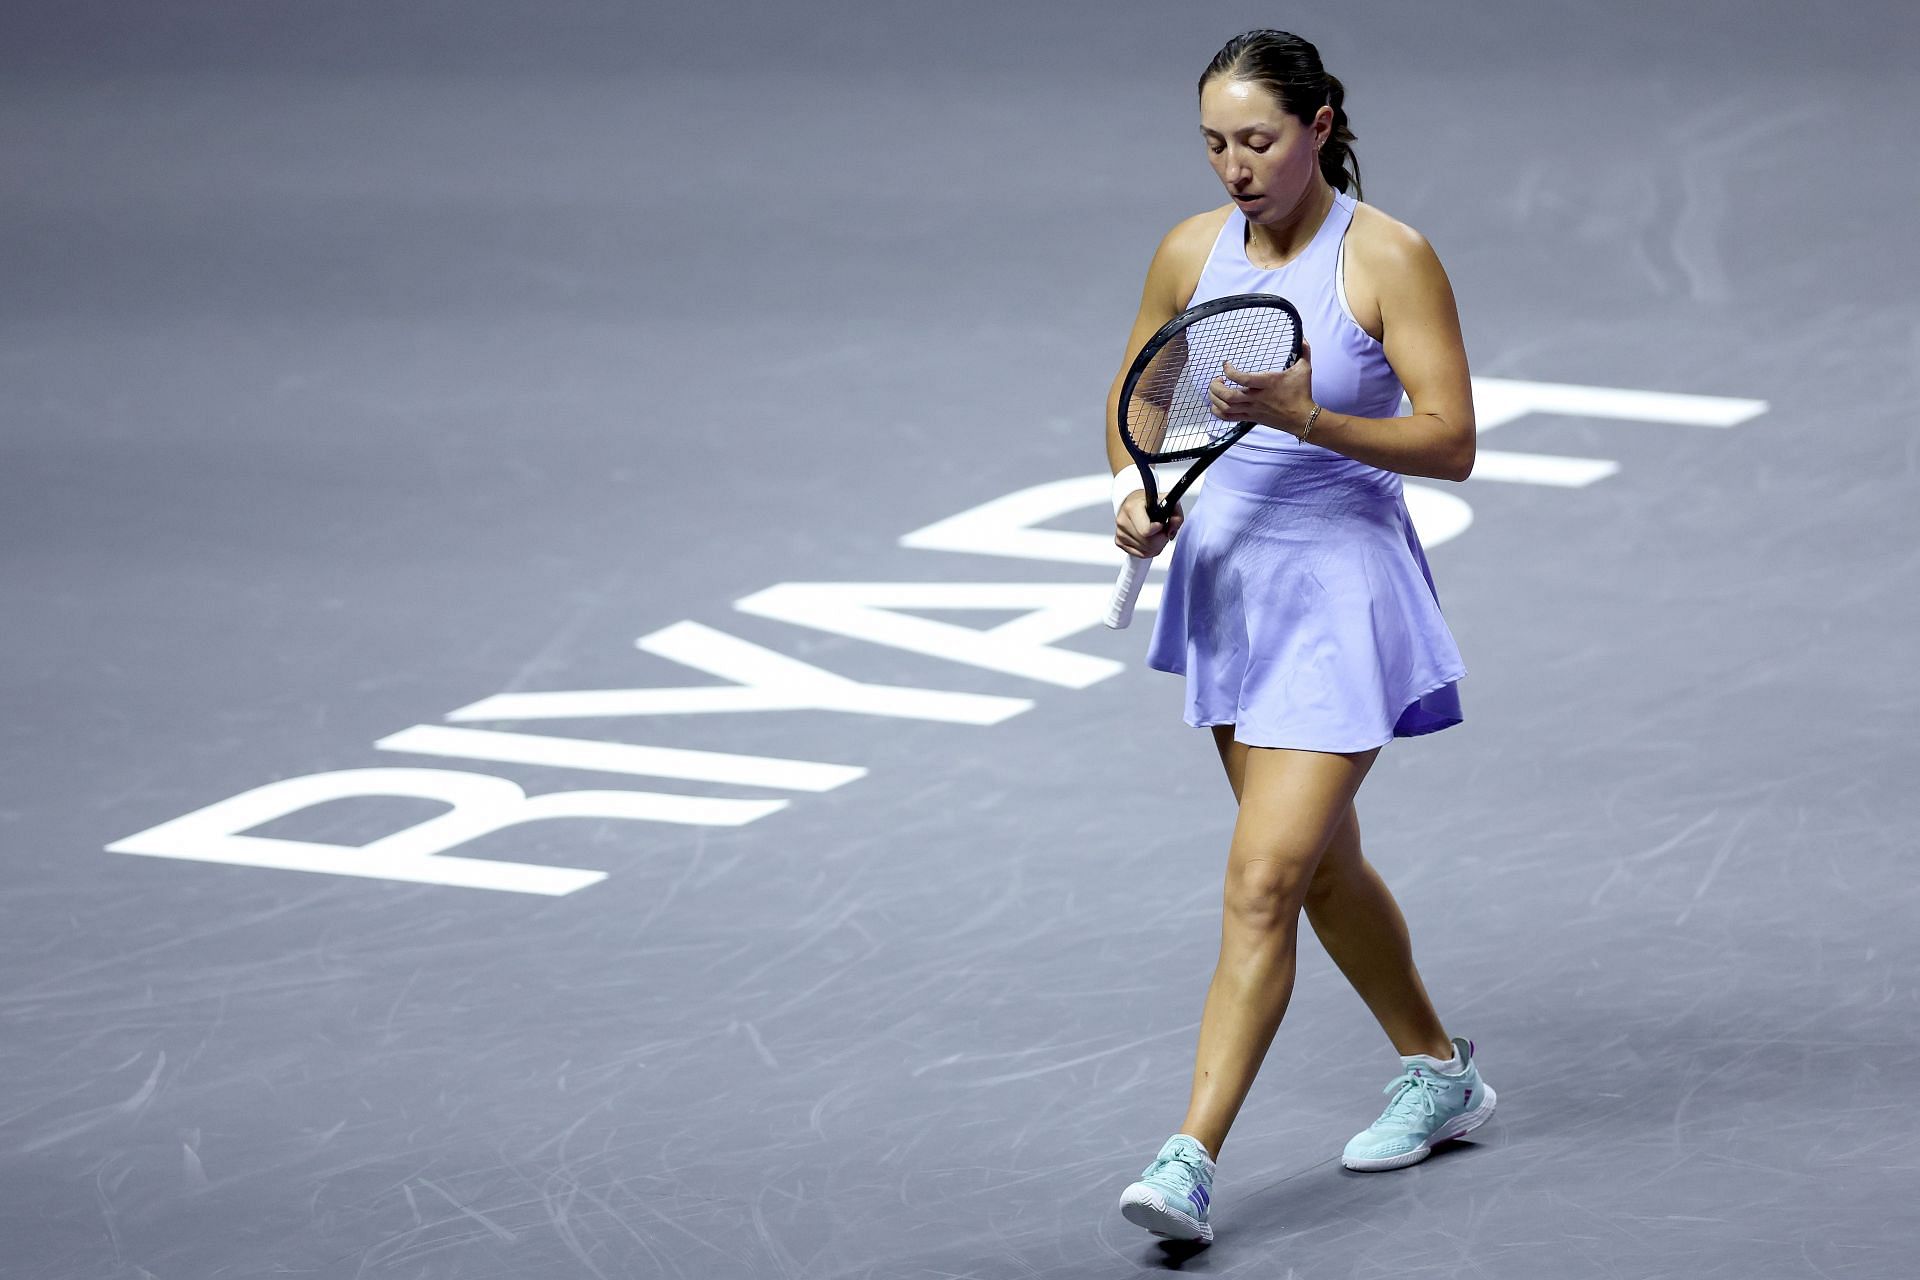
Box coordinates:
[1213,223,1475,480]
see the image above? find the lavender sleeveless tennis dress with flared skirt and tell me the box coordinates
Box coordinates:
[1146,192,1467,752]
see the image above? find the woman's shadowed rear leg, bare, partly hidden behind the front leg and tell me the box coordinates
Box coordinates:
[1306,804,1453,1061]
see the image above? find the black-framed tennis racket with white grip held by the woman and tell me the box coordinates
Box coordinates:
[1106,294,1300,631]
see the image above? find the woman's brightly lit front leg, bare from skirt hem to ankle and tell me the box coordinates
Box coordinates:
[1181,729,1379,1159]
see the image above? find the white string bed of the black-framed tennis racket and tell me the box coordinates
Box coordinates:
[1121,307,1296,459]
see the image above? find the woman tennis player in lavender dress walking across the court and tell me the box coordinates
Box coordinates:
[1106,31,1494,1240]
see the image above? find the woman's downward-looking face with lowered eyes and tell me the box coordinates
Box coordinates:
[1200,75,1332,223]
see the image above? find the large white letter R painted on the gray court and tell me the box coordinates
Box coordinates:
[108,770,785,896]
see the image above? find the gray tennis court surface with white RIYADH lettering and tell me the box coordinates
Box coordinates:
[0,0,1920,1280]
